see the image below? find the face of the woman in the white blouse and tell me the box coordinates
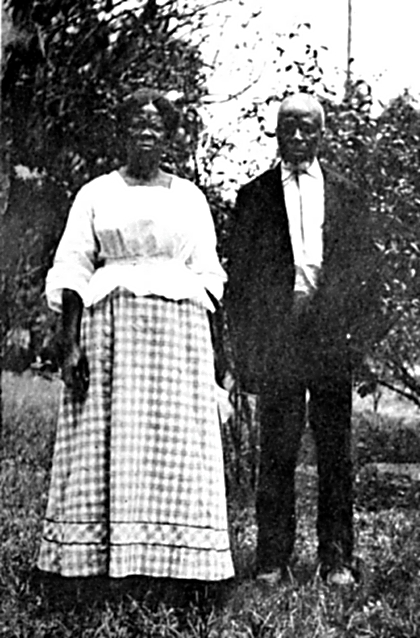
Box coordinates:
[126,104,168,161]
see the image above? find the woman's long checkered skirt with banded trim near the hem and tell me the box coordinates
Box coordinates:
[38,288,233,580]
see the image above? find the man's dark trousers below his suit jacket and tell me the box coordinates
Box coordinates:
[256,322,353,572]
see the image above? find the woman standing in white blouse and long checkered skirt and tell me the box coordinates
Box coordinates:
[38,90,233,592]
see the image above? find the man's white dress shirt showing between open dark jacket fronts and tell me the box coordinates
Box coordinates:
[281,160,324,294]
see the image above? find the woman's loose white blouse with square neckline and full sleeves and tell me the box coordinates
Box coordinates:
[46,171,226,312]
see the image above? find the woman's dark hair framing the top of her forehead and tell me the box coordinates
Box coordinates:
[118,89,180,136]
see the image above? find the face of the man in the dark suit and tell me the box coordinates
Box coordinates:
[277,107,322,166]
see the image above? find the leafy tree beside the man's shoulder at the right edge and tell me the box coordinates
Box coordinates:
[325,82,420,407]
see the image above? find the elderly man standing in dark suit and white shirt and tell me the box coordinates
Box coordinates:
[226,94,374,585]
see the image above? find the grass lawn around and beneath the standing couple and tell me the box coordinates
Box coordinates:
[0,374,420,638]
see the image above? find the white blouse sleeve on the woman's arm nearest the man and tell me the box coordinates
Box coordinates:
[187,188,226,308]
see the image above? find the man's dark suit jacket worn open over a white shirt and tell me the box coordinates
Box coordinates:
[225,165,377,392]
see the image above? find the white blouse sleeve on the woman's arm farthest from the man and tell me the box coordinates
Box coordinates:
[45,187,97,312]
